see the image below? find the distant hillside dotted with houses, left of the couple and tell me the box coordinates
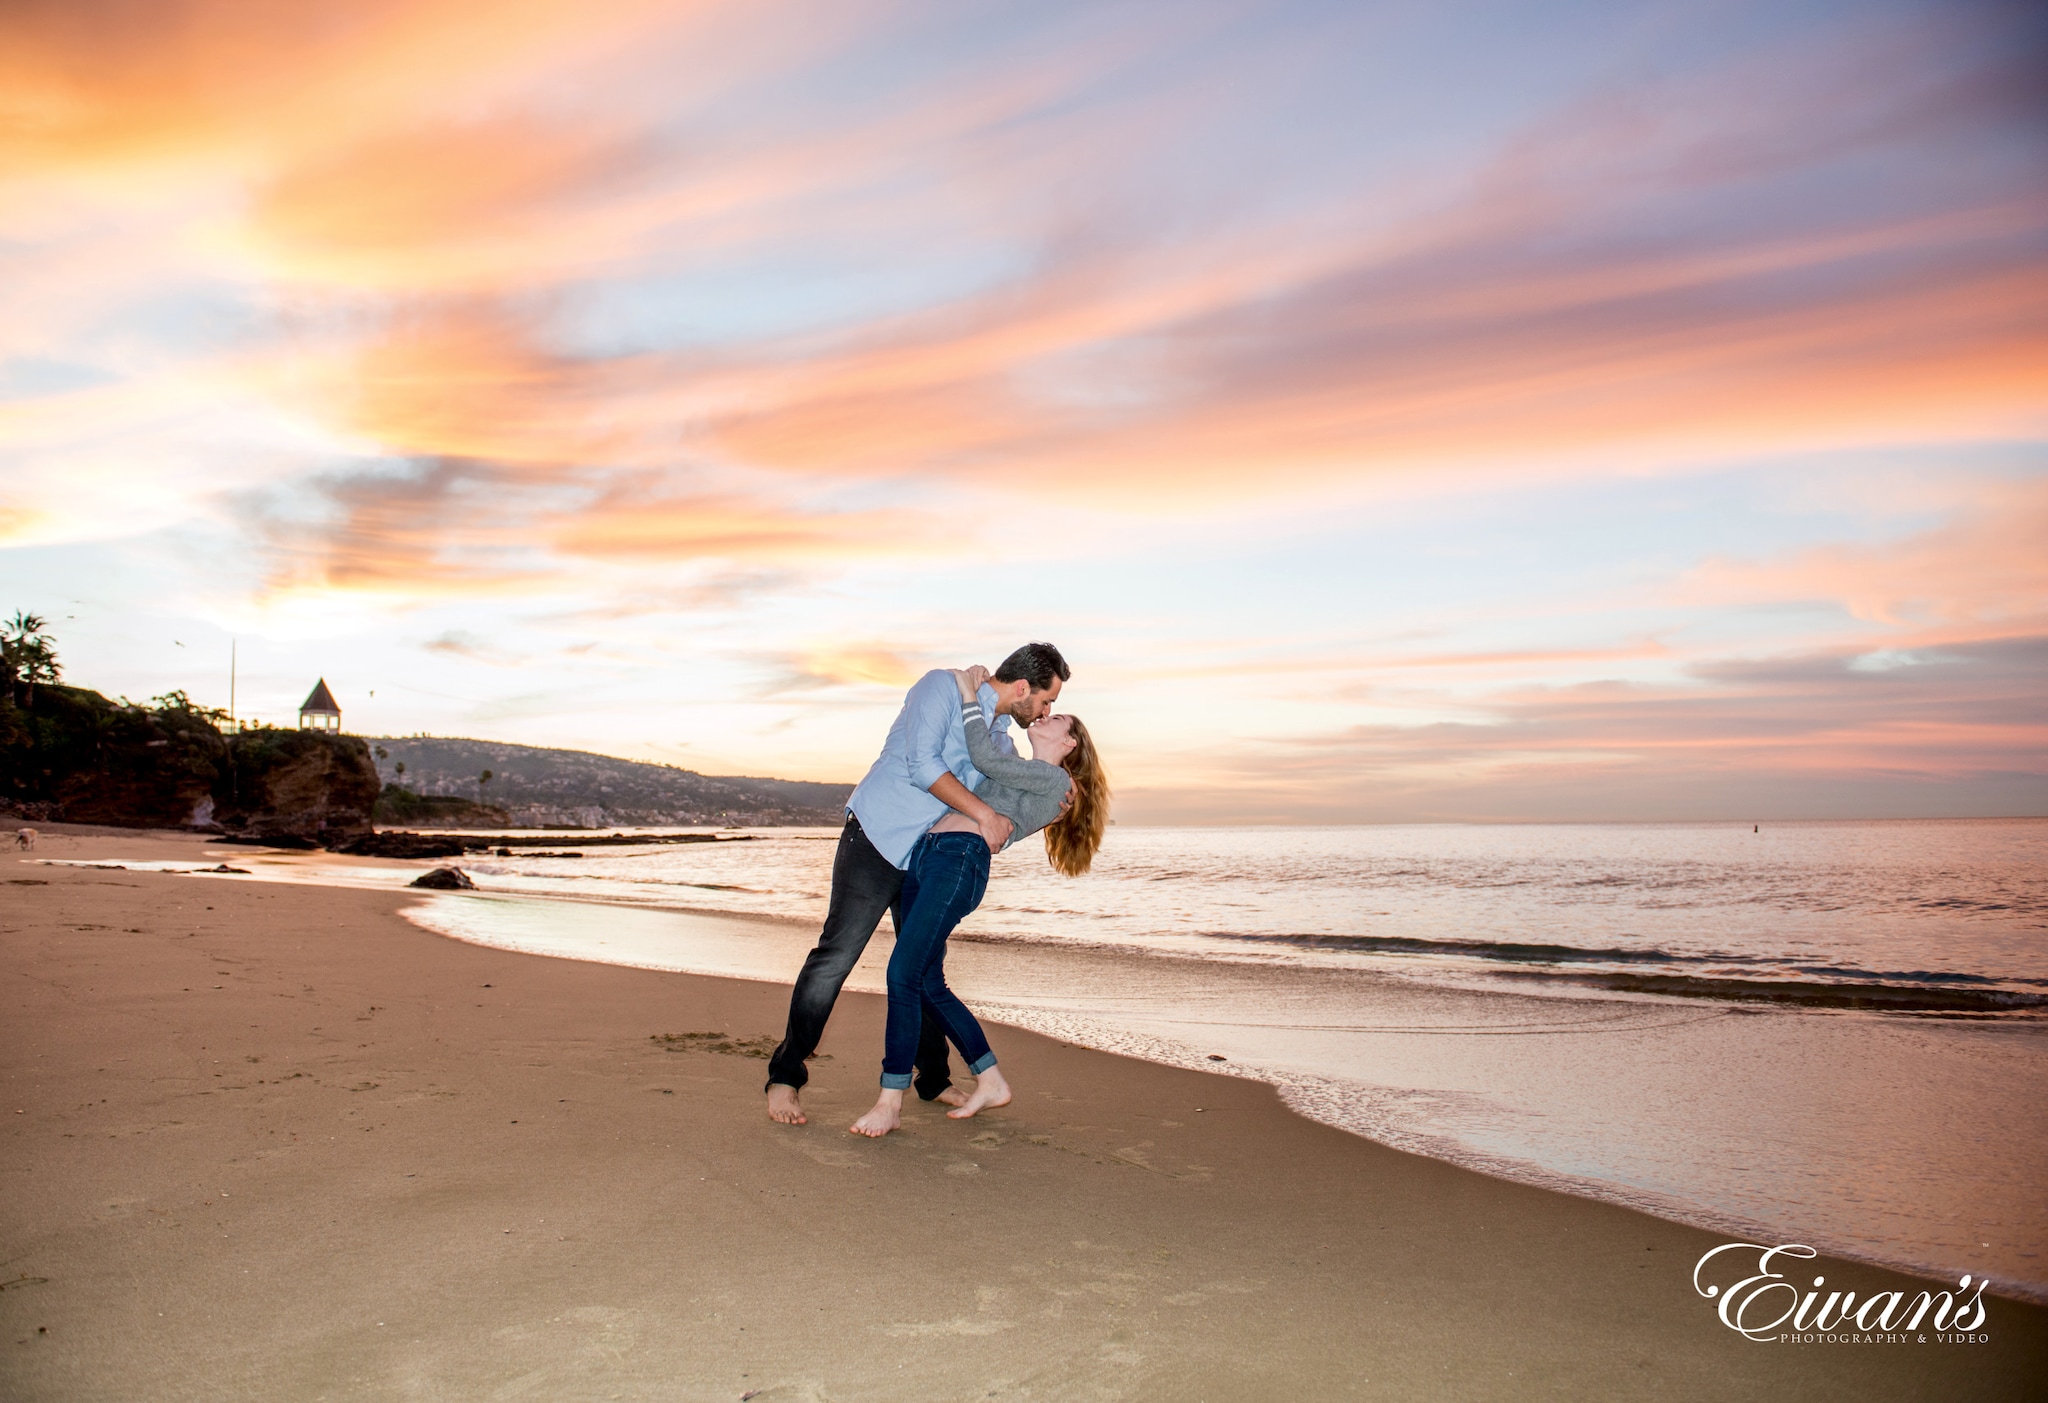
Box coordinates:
[369,735,854,827]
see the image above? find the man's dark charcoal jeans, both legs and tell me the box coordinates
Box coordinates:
[768,813,952,1100]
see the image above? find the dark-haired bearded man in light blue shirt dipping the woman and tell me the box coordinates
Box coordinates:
[768,643,1069,1124]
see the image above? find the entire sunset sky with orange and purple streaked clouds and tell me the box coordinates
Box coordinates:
[0,0,2048,823]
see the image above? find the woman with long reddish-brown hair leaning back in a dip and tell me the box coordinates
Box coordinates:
[852,668,1110,1137]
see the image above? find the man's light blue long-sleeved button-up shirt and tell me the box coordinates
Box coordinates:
[846,670,1016,866]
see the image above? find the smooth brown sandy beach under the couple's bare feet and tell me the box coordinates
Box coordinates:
[0,830,2048,1401]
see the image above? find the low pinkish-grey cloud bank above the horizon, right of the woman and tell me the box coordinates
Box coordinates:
[1124,637,2048,821]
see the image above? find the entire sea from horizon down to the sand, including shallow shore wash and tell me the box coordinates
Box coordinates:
[72,821,2048,1299]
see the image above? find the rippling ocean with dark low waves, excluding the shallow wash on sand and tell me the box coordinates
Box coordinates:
[436,821,2048,1018]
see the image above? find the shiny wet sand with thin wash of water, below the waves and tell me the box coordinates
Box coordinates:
[410,895,2048,1296]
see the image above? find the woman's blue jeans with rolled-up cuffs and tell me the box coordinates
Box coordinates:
[883,834,995,1090]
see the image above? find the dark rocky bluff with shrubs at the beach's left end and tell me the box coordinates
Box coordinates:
[0,686,379,848]
